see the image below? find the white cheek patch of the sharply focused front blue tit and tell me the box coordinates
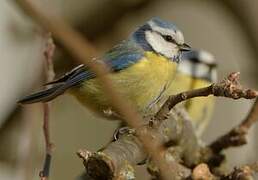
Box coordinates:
[145,31,179,58]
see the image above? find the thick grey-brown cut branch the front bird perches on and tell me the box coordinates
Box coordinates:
[76,108,200,179]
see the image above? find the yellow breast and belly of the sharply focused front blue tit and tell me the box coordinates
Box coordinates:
[72,52,177,118]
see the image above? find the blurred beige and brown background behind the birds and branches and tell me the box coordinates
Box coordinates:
[0,0,258,180]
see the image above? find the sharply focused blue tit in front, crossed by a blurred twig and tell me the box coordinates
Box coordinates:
[19,18,190,119]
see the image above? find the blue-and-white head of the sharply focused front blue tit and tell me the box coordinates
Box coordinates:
[132,18,190,61]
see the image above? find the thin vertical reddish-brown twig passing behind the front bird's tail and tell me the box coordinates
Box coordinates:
[39,33,55,180]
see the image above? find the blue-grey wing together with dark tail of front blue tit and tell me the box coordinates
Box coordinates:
[18,41,144,104]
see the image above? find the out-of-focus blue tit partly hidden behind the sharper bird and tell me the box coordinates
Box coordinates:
[167,50,217,136]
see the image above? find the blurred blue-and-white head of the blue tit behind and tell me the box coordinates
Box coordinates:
[178,50,217,83]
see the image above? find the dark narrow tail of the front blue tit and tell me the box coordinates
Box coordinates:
[18,84,65,104]
